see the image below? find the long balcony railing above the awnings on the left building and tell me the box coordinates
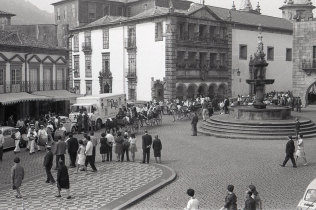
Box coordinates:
[0,80,69,93]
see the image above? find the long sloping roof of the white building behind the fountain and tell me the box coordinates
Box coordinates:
[208,6,293,31]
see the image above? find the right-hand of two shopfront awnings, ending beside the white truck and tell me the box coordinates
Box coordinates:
[32,90,82,101]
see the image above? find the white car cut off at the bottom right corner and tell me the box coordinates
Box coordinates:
[296,178,316,210]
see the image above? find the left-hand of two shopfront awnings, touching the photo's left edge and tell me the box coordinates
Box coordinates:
[0,92,51,105]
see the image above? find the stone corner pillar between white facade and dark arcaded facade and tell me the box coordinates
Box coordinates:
[164,16,177,99]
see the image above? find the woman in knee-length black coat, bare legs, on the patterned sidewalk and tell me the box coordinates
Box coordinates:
[55,160,71,199]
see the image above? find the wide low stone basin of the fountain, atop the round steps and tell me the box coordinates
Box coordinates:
[230,105,291,120]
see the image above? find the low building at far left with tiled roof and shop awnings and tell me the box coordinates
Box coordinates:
[0,30,76,123]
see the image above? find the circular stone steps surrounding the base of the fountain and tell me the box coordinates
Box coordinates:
[199,115,316,140]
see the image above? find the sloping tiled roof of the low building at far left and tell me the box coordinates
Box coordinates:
[0,30,65,50]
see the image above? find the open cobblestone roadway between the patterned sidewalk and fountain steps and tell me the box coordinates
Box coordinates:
[131,107,316,210]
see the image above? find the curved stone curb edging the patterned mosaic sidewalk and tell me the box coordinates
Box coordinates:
[100,163,177,210]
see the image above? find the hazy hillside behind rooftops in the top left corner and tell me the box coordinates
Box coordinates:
[0,0,54,25]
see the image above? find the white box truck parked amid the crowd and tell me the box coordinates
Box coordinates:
[69,93,126,130]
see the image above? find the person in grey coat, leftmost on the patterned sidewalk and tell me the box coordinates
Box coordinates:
[11,157,24,198]
